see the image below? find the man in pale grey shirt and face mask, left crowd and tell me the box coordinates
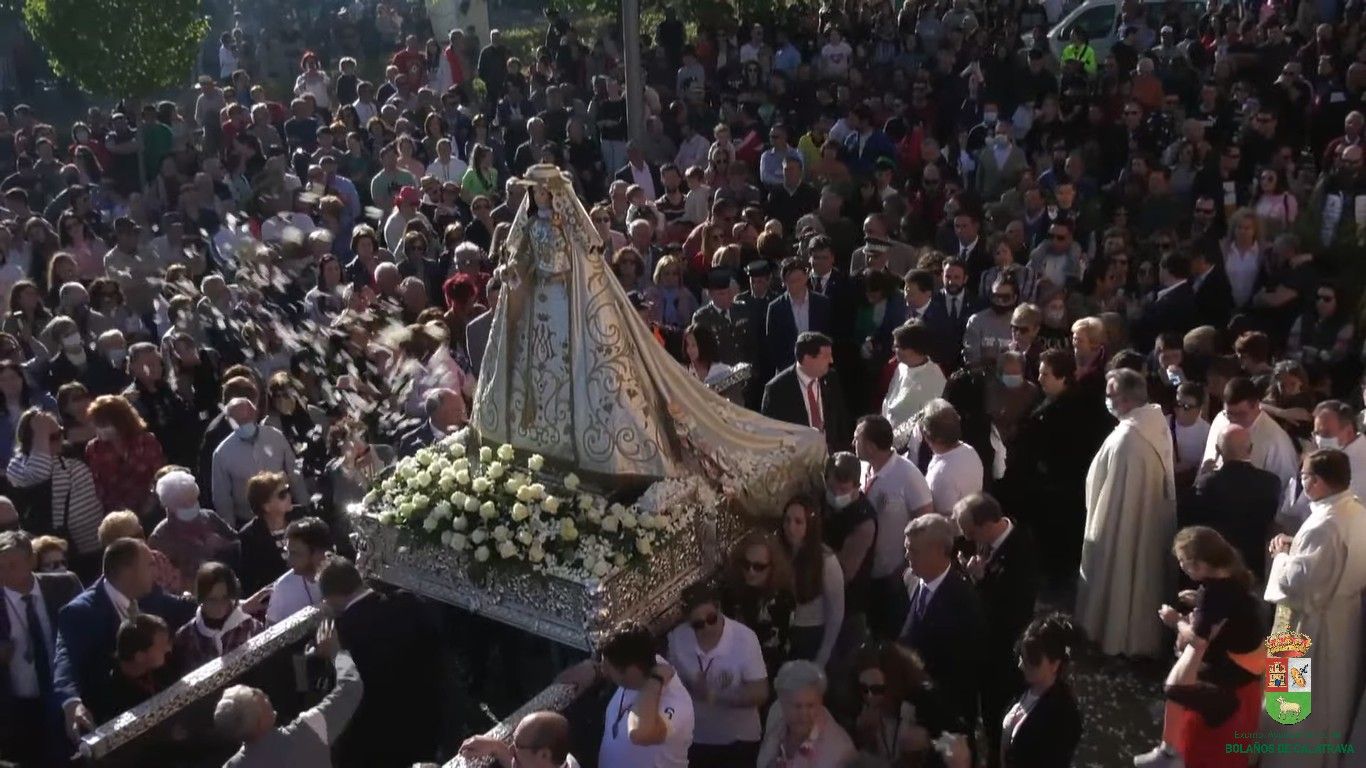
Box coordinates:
[210,398,309,526]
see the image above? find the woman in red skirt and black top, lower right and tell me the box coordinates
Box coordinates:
[1134,526,1266,768]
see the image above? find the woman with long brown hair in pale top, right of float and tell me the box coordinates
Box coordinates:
[779,496,844,667]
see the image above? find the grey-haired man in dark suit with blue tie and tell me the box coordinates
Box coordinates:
[897,515,988,734]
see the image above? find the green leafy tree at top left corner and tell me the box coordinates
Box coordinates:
[23,0,209,98]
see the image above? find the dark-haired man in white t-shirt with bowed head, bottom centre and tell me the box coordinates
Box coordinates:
[559,622,693,768]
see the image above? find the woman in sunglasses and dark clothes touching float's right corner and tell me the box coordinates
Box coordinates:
[721,529,796,676]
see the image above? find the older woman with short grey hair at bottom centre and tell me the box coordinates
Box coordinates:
[758,660,855,768]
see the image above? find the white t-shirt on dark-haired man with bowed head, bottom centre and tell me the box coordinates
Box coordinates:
[598,659,693,768]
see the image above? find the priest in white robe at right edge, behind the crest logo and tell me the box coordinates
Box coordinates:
[1262,450,1366,768]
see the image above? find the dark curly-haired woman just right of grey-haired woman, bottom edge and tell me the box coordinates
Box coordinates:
[850,642,966,765]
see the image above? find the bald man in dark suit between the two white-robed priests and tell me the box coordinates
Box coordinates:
[1177,424,1281,579]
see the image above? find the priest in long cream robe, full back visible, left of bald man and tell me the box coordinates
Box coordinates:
[1076,369,1176,656]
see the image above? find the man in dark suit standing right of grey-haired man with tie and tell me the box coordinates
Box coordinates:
[953,493,1038,765]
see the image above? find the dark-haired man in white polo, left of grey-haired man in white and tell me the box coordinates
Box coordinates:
[854,415,934,638]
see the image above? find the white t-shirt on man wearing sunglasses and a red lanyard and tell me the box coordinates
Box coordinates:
[669,609,768,745]
